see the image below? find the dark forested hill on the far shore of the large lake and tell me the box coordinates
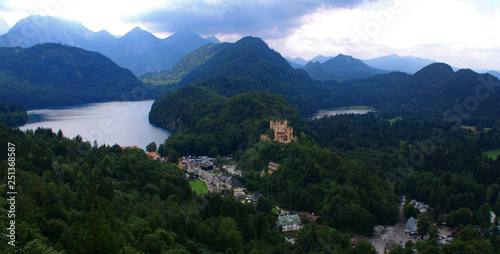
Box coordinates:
[0,43,143,108]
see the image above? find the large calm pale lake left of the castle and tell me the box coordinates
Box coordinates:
[20,100,171,149]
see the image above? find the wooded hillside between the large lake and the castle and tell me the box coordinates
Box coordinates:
[149,85,301,156]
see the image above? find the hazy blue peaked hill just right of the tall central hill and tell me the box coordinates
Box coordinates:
[303,54,389,81]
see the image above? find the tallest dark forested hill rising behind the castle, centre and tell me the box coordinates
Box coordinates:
[145,37,339,115]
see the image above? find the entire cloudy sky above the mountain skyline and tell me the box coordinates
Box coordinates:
[0,0,500,70]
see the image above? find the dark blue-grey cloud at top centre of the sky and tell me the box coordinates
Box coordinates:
[126,0,375,38]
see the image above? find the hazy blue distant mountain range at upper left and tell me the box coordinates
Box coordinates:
[0,15,219,76]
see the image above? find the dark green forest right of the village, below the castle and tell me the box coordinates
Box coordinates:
[238,114,500,253]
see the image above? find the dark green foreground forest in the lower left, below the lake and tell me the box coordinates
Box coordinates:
[0,127,292,253]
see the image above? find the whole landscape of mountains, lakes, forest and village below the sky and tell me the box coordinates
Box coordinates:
[0,13,500,254]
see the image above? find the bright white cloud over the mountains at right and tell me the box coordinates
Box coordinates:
[274,0,500,69]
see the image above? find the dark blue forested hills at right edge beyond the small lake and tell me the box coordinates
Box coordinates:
[332,63,500,127]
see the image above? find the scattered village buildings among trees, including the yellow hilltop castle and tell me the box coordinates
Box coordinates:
[129,120,484,253]
